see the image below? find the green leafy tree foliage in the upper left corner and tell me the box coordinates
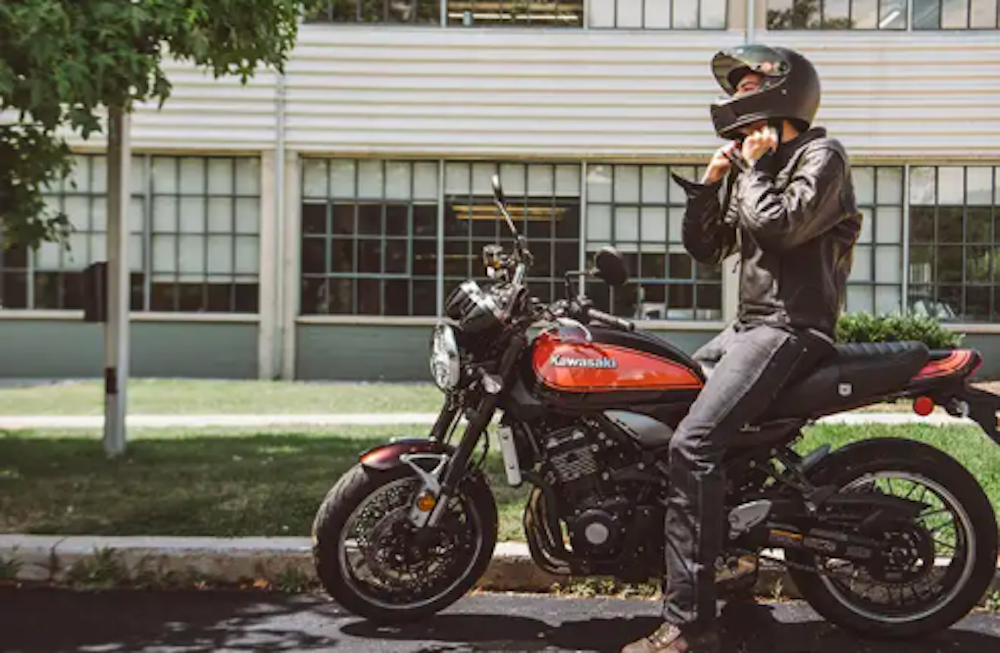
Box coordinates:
[0,0,323,246]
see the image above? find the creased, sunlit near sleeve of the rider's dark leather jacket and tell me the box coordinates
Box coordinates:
[737,147,847,250]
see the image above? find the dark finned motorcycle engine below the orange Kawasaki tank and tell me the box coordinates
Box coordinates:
[542,423,631,557]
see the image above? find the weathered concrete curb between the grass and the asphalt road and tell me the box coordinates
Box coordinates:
[0,535,1000,599]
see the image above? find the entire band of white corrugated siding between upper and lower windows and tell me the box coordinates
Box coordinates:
[45,25,1000,160]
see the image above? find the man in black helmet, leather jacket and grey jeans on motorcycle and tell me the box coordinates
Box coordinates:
[623,45,861,653]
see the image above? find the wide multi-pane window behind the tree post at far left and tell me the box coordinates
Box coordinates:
[0,155,260,313]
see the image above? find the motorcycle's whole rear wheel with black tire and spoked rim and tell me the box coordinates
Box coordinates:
[786,439,997,639]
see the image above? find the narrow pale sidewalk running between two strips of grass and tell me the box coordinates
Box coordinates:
[0,413,974,430]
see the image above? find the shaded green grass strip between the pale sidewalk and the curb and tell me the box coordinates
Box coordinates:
[0,426,1000,540]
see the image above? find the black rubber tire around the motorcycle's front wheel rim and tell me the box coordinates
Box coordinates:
[312,464,499,624]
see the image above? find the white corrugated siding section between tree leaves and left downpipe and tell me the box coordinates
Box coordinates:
[60,60,277,151]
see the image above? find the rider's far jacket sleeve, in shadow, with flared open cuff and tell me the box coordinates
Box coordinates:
[672,174,736,265]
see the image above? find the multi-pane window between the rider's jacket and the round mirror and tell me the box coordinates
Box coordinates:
[586,165,722,320]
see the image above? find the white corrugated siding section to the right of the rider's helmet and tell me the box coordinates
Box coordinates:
[766,32,1000,161]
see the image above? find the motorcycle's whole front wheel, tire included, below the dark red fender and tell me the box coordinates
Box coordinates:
[313,464,497,623]
